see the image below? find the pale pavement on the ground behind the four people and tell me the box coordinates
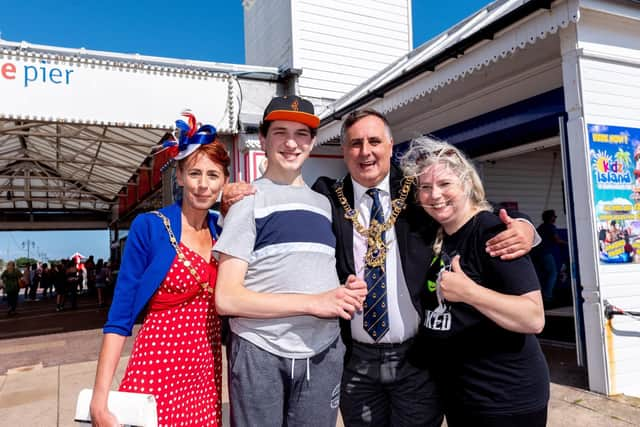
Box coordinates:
[0,290,640,427]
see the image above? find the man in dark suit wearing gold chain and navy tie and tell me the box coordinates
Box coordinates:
[313,110,534,427]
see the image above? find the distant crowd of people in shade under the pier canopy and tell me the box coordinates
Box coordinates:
[0,255,114,316]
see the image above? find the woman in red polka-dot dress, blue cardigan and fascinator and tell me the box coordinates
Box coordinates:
[90,113,229,427]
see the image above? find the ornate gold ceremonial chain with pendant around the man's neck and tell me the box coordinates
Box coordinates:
[335,177,415,268]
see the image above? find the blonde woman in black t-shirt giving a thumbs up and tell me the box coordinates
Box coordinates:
[402,138,549,427]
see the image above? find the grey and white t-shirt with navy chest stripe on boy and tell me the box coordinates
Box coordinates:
[214,178,339,358]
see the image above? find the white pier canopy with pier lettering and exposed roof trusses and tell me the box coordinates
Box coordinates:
[0,40,278,229]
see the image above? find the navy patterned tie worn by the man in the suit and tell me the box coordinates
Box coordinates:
[362,188,389,341]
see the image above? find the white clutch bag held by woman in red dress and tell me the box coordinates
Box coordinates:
[75,388,158,427]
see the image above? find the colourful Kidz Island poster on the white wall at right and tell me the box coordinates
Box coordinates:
[588,124,640,264]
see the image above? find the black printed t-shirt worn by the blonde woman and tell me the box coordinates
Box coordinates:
[420,212,549,414]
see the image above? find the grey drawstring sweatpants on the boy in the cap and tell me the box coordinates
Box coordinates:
[228,334,344,427]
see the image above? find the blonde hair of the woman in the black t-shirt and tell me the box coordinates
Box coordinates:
[400,136,492,256]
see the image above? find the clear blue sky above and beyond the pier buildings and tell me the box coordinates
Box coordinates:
[0,0,490,259]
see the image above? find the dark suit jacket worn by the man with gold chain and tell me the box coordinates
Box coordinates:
[312,165,437,357]
